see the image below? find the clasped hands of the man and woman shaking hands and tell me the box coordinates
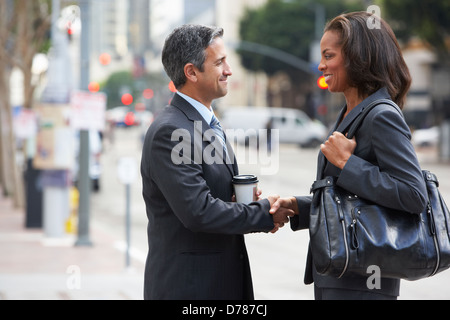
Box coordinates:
[267,196,299,233]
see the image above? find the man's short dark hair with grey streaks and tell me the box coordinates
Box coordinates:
[162,24,223,89]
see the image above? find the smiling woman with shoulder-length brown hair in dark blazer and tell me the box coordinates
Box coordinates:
[272,12,426,300]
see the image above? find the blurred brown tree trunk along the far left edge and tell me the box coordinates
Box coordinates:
[0,0,51,207]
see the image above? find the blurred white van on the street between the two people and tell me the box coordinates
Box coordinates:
[220,107,328,148]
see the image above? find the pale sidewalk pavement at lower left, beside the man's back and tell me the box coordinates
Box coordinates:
[0,192,144,300]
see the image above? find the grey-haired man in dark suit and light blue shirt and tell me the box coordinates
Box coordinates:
[141,25,293,299]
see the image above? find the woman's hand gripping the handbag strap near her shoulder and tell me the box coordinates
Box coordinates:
[320,131,356,170]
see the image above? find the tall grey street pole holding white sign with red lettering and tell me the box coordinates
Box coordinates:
[75,0,92,246]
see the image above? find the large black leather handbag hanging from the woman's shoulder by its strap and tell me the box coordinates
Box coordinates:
[309,100,450,280]
